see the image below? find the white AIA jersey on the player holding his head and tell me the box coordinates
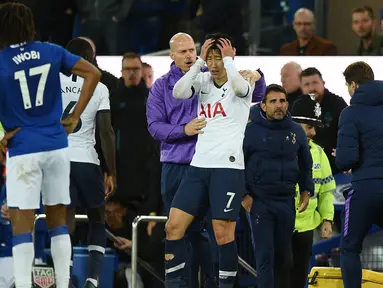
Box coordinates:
[191,72,254,169]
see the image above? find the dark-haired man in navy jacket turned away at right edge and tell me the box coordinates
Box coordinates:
[336,62,383,288]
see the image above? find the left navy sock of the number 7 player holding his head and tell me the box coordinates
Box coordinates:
[165,238,190,288]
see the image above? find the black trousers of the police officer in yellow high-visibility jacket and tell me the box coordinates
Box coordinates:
[290,230,314,288]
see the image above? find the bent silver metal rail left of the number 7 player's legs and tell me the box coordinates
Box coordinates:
[132,216,168,288]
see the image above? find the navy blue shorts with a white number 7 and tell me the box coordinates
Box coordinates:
[172,166,245,221]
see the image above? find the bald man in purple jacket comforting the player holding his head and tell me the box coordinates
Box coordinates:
[147,33,216,288]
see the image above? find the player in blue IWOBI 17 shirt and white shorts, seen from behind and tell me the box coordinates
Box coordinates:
[0,3,100,288]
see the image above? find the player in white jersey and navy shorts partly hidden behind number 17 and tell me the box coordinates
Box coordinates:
[61,38,116,287]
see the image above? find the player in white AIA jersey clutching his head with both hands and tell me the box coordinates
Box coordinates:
[165,34,261,288]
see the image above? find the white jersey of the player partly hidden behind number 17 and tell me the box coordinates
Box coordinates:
[60,74,110,165]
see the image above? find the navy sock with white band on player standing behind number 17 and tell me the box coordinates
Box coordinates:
[87,221,106,286]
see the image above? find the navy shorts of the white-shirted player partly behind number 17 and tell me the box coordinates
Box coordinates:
[70,162,105,208]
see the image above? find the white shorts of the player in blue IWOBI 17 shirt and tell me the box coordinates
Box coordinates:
[6,148,70,210]
